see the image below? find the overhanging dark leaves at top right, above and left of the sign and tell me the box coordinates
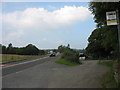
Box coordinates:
[89,2,119,27]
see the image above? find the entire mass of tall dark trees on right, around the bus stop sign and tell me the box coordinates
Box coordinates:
[86,2,119,59]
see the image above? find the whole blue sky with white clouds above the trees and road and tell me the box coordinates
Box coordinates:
[0,2,96,49]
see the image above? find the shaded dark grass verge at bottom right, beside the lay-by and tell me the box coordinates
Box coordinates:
[99,61,118,88]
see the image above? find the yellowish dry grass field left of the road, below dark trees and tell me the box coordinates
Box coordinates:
[0,54,47,63]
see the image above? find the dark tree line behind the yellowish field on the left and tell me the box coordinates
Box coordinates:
[0,43,45,55]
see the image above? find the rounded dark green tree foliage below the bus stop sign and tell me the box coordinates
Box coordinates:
[86,26,118,58]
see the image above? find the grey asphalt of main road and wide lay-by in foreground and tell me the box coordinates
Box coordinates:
[1,56,109,88]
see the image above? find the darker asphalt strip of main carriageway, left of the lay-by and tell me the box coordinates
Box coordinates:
[2,55,60,76]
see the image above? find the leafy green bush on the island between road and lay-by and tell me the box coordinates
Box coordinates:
[62,48,80,63]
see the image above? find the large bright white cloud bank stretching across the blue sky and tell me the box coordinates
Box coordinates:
[0,6,91,41]
